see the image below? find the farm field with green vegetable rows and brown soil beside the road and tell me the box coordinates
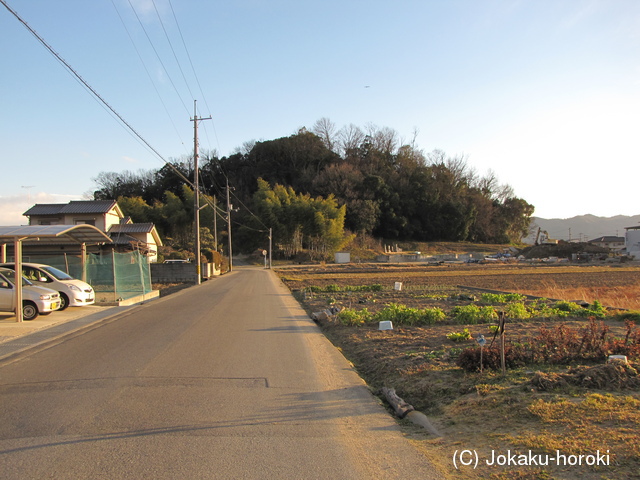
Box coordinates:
[276,264,640,479]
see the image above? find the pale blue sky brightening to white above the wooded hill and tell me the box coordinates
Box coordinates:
[0,0,640,225]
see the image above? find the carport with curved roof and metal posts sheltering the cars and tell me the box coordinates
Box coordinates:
[0,224,111,322]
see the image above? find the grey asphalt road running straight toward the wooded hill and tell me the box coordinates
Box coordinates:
[0,268,438,480]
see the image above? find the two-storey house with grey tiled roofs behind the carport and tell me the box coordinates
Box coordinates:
[23,200,162,262]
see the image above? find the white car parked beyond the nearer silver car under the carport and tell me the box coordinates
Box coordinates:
[0,263,95,310]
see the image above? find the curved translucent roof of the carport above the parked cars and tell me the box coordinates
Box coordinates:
[0,224,111,244]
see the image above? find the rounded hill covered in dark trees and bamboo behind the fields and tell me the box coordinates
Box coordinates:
[94,119,534,253]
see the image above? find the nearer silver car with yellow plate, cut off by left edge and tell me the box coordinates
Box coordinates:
[0,268,60,320]
